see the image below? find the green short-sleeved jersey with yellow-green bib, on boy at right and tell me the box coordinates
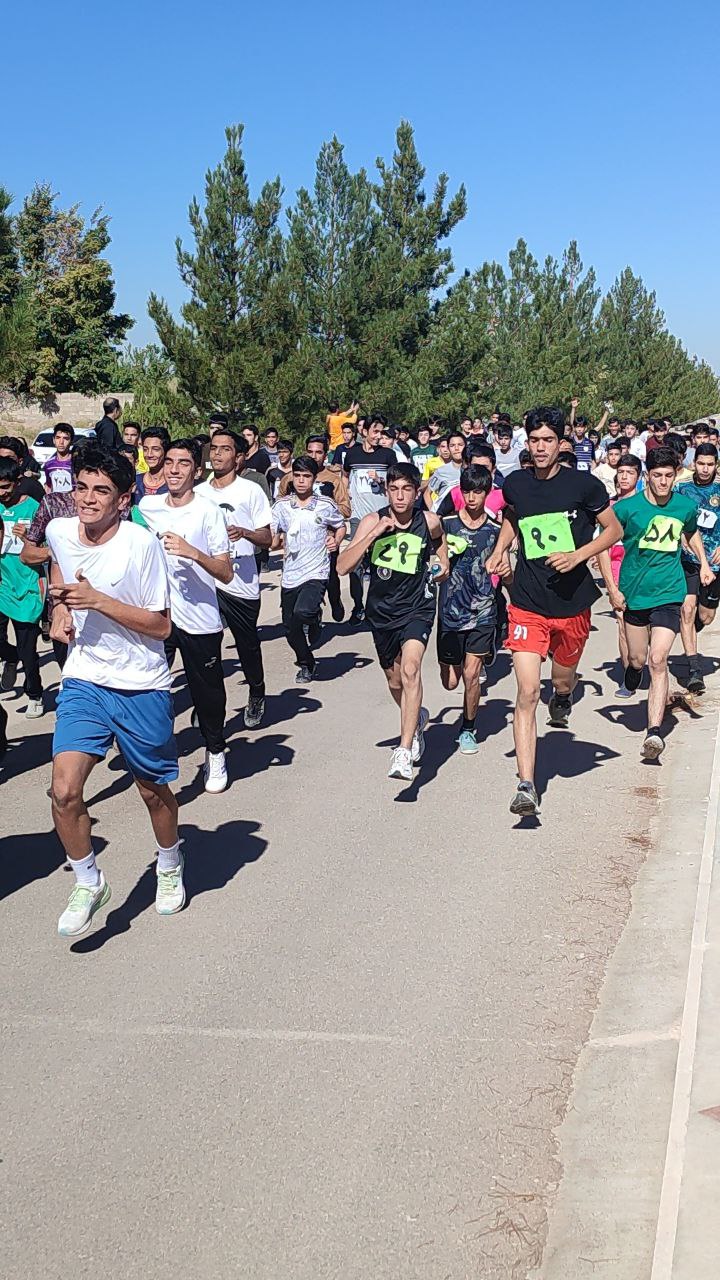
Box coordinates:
[612,490,697,609]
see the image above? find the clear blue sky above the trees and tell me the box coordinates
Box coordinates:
[0,0,720,369]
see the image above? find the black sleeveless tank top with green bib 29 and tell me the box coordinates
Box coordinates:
[365,507,436,630]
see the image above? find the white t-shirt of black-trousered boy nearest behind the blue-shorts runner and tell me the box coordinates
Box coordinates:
[140,493,231,636]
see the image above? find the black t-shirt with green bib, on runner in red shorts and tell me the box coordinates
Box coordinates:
[502,467,610,618]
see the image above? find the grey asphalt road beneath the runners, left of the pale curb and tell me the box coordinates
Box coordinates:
[0,575,673,1280]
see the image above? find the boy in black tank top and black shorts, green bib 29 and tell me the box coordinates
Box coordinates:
[337,462,450,782]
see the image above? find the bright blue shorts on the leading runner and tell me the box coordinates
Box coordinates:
[53,680,178,783]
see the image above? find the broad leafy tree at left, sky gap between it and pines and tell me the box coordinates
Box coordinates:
[15,186,132,396]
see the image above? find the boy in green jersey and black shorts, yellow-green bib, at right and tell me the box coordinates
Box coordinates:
[602,447,715,760]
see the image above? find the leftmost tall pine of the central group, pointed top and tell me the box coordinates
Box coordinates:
[149,125,295,421]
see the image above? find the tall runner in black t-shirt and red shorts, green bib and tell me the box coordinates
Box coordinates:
[486,407,623,817]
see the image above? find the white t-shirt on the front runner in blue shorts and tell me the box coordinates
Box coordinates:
[45,516,170,692]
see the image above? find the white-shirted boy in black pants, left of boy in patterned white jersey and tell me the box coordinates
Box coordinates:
[195,430,273,728]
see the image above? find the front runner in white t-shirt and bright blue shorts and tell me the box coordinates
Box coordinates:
[46,445,184,938]
